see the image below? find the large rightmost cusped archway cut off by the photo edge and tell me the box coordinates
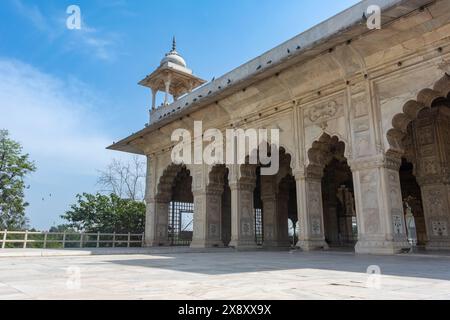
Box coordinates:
[386,74,450,249]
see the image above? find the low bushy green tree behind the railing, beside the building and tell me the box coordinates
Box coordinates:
[61,193,145,233]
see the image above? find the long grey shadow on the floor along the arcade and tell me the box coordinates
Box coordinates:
[103,251,450,281]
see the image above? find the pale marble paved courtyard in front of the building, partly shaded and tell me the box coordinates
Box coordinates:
[0,251,450,299]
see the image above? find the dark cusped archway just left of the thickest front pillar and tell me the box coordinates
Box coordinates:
[307,133,357,247]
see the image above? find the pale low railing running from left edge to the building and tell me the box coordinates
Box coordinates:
[0,230,144,249]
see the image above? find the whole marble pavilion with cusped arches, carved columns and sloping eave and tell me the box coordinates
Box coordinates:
[110,0,450,254]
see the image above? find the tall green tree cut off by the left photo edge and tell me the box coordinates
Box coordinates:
[0,130,36,229]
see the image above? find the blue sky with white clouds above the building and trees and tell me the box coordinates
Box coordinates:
[0,0,358,229]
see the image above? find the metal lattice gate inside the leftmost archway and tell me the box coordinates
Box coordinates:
[168,201,194,246]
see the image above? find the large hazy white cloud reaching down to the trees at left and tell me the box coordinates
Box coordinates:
[0,57,135,229]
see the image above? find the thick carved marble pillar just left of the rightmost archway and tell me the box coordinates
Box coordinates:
[350,155,410,254]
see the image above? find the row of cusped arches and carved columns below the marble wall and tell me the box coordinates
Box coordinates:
[142,74,450,253]
